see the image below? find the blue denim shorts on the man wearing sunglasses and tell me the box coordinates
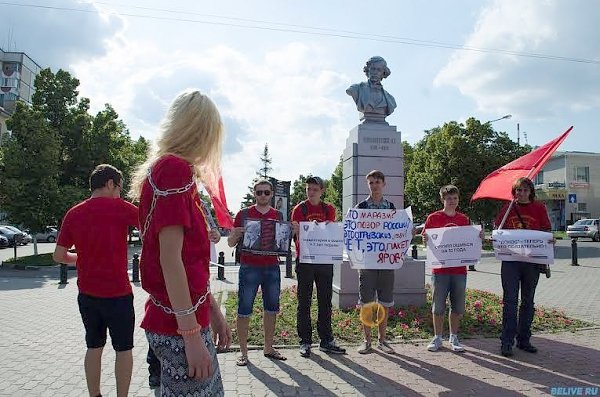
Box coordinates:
[238,264,281,317]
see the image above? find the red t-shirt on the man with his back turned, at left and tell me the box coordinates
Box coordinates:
[56,197,138,298]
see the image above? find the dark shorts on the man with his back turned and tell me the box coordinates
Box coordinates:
[77,293,135,351]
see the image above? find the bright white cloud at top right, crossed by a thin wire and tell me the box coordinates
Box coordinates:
[434,0,600,119]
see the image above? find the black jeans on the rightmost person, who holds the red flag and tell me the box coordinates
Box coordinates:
[500,262,540,346]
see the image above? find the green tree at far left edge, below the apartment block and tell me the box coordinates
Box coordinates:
[0,103,60,254]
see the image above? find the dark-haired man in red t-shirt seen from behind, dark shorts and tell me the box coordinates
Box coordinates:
[52,164,139,396]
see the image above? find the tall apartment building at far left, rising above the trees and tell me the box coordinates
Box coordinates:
[0,49,42,144]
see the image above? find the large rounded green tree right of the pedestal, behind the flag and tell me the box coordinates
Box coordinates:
[405,118,531,223]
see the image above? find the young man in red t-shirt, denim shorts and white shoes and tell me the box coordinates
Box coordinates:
[422,185,480,352]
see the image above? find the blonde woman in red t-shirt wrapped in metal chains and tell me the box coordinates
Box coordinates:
[130,91,231,396]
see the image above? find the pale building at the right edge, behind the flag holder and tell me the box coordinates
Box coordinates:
[534,152,600,230]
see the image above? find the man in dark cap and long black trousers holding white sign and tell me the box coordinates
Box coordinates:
[292,176,346,357]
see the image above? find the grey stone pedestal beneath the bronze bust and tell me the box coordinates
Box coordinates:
[333,122,426,308]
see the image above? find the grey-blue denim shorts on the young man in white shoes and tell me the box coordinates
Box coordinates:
[431,274,467,315]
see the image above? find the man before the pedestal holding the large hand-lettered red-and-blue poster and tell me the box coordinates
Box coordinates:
[356,170,395,354]
